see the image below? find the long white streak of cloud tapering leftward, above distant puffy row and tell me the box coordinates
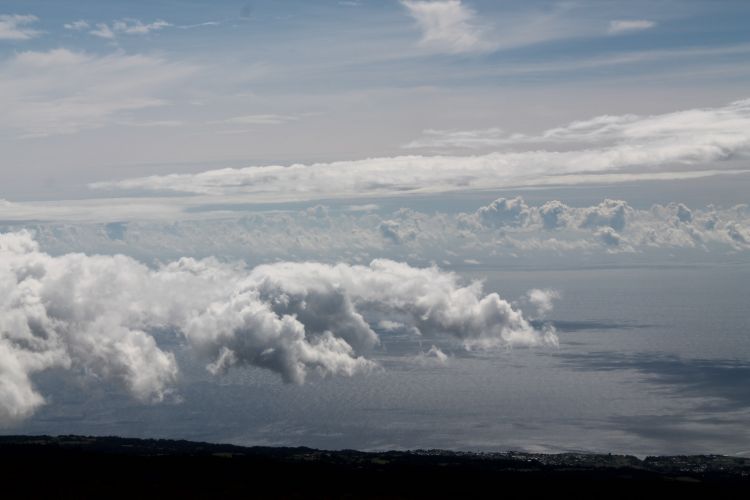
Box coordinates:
[91,100,750,201]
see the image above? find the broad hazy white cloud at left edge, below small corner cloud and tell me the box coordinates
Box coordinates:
[0,49,195,136]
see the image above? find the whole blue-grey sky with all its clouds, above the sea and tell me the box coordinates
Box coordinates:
[0,0,750,451]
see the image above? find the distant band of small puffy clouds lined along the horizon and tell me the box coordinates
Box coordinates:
[16,197,750,264]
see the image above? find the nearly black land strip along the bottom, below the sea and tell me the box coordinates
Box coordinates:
[0,436,750,498]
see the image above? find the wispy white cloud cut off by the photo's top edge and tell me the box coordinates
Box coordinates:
[401,0,492,53]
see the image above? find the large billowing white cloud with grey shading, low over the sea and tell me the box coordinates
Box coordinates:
[0,232,557,424]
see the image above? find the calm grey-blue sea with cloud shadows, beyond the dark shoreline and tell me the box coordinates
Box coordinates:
[10,266,750,455]
